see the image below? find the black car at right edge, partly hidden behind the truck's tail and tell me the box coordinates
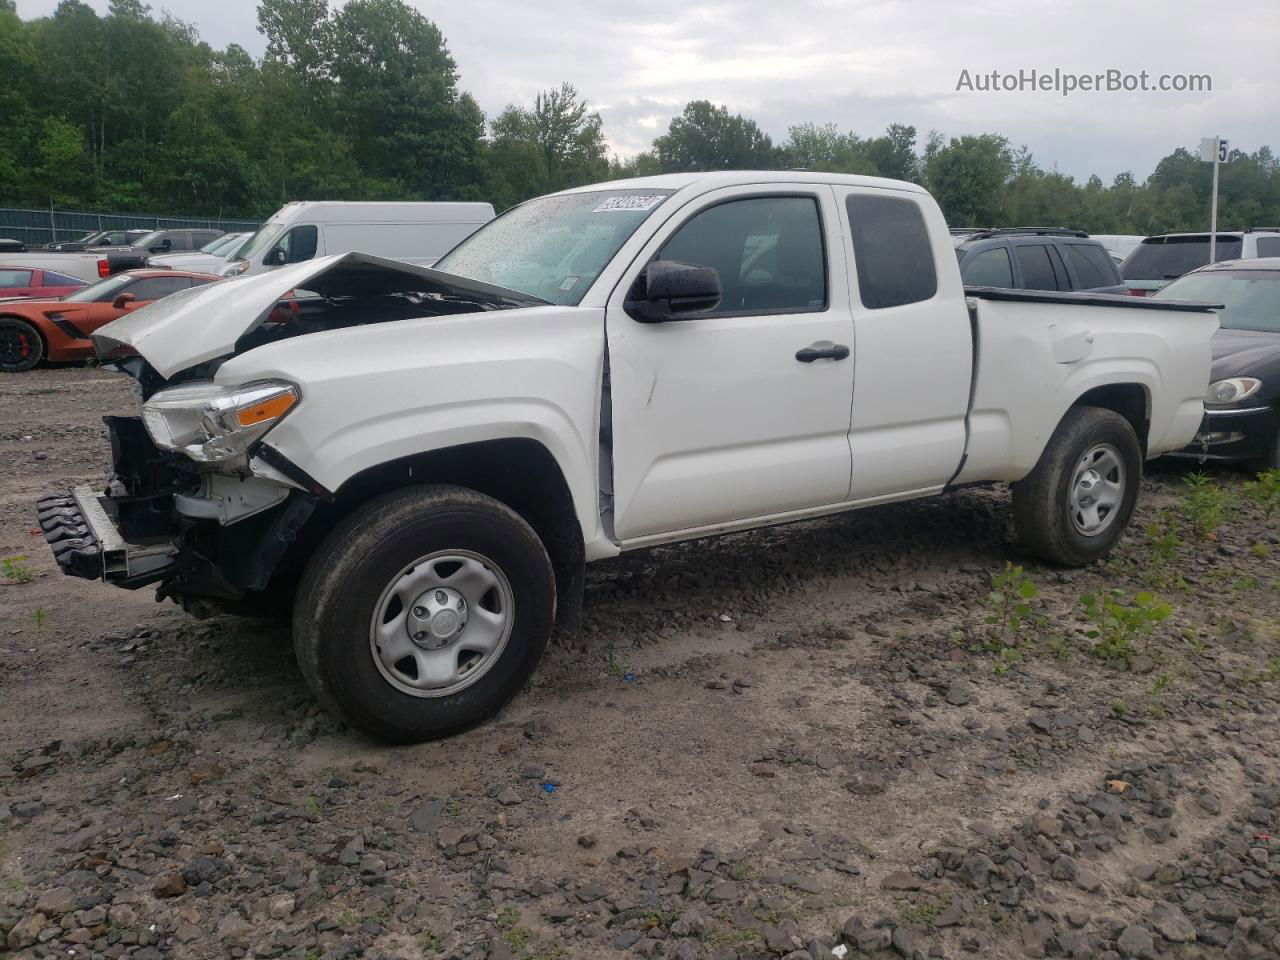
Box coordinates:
[1155,257,1280,470]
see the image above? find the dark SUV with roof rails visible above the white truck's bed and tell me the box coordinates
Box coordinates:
[952,227,1128,293]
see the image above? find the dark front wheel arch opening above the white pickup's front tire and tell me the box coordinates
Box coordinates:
[291,438,585,631]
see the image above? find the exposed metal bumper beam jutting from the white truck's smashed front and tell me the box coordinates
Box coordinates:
[36,486,178,589]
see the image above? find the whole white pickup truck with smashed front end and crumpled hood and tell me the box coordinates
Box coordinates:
[40,173,1217,741]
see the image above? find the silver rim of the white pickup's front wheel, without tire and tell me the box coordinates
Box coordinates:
[369,550,516,696]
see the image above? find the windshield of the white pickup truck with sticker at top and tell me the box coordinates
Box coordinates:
[435,188,673,306]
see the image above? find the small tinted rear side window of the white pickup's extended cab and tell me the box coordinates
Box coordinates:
[845,193,938,310]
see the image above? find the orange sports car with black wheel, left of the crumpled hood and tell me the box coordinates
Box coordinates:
[0,270,221,374]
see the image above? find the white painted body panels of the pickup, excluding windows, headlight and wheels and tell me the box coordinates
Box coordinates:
[104,172,1217,559]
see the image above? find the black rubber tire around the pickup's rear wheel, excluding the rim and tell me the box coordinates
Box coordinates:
[1012,407,1142,567]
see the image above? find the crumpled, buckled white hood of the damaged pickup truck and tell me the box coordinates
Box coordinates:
[93,253,545,379]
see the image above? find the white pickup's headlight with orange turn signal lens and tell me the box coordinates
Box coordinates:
[142,380,300,463]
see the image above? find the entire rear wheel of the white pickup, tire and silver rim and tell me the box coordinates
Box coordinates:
[1012,407,1142,567]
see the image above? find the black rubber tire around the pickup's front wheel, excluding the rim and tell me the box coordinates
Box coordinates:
[293,485,556,744]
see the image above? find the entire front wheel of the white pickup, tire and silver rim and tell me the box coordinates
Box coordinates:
[293,485,556,744]
